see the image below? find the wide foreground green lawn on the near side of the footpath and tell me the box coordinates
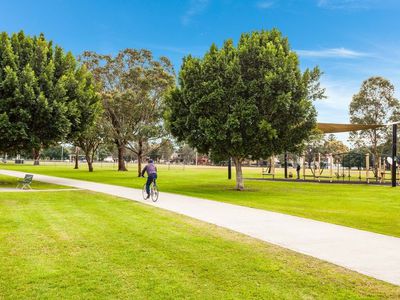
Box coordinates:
[0,191,400,299]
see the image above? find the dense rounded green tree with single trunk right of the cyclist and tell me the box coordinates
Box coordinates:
[167,30,323,190]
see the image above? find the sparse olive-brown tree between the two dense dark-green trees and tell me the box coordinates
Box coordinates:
[80,49,174,171]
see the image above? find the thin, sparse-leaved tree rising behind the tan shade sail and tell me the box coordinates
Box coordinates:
[350,77,400,169]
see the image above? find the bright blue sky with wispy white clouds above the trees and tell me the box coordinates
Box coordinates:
[0,0,400,141]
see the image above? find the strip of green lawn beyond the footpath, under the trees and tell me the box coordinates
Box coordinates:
[1,164,400,237]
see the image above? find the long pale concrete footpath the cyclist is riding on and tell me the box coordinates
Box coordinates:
[0,170,400,285]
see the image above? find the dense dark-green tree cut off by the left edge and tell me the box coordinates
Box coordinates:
[0,31,96,164]
